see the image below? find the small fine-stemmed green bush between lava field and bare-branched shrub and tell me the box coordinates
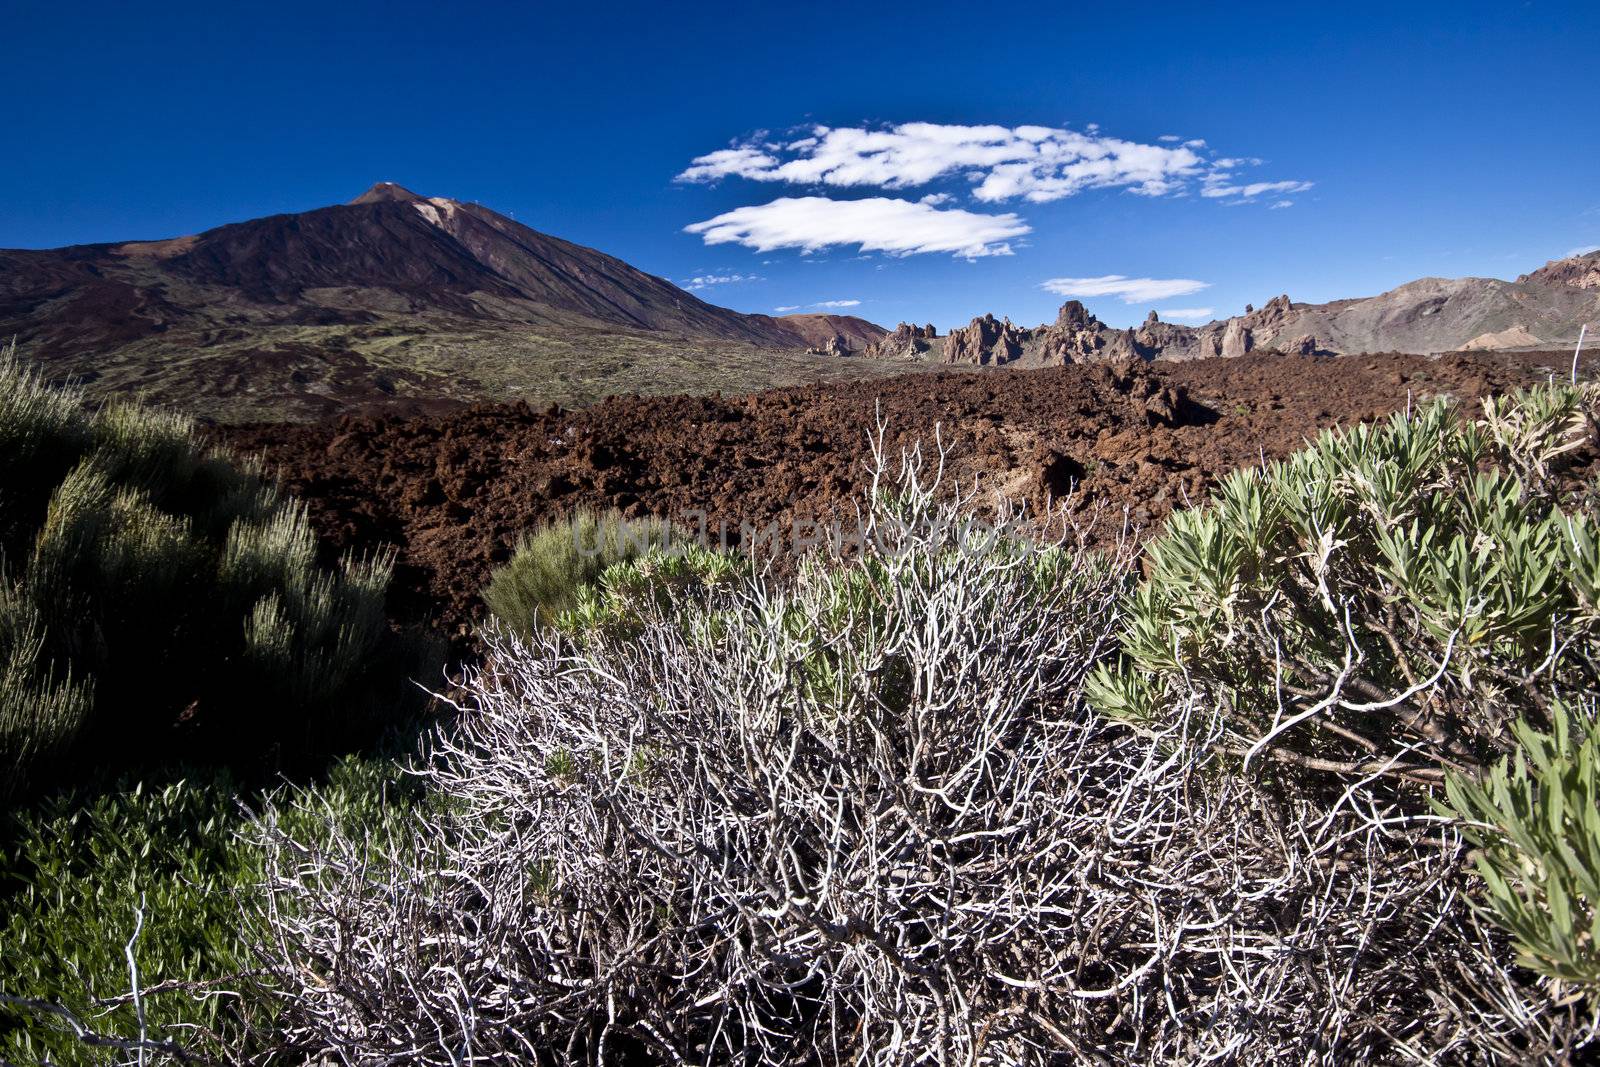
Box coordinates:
[483,510,675,637]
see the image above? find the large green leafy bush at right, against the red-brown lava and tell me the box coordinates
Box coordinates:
[1091,386,1600,776]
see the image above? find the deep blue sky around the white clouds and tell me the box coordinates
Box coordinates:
[0,0,1600,328]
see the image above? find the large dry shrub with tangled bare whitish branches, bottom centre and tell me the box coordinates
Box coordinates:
[258,431,1592,1064]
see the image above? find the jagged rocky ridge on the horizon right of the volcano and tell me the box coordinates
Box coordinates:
[866,251,1600,366]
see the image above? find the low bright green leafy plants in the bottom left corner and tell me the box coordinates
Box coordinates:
[0,758,418,1064]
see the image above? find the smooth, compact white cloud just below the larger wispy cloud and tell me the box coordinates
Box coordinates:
[683,197,1032,259]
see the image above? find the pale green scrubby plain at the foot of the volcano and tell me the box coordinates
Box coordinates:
[21,312,936,424]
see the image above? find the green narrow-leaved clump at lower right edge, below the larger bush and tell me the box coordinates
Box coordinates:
[1443,702,1600,997]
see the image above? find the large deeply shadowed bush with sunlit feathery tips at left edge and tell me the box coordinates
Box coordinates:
[0,354,430,801]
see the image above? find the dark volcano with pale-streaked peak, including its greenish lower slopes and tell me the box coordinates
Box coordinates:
[0,182,893,421]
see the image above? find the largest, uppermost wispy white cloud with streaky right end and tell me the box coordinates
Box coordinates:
[677,122,1309,206]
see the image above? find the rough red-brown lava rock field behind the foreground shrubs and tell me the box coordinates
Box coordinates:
[224,354,1600,641]
